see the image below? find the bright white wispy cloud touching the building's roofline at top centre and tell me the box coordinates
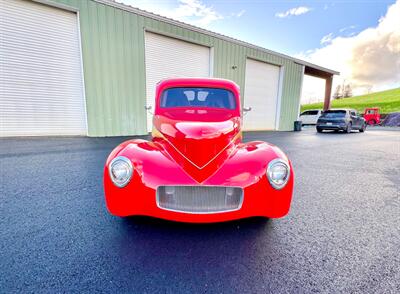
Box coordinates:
[118,0,225,27]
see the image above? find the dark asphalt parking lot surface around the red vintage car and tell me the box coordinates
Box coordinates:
[0,128,400,293]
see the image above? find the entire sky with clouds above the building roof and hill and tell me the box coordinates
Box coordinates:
[118,0,400,103]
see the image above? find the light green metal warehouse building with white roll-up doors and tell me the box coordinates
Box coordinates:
[0,0,337,136]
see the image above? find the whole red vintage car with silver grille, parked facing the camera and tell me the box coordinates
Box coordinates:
[104,78,294,223]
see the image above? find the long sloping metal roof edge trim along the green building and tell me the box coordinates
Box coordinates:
[93,0,340,75]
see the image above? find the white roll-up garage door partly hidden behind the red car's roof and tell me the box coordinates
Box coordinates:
[146,32,211,131]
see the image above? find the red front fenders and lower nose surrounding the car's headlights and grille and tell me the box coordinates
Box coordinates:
[104,140,294,221]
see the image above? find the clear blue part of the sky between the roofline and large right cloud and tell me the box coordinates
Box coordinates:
[164,1,395,55]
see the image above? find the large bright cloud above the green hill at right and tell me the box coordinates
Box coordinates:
[296,0,400,99]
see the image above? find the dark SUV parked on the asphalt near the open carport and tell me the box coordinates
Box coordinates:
[316,109,367,133]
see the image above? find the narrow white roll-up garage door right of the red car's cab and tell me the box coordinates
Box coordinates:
[244,59,280,130]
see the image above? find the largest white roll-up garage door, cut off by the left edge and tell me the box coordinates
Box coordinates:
[0,0,86,136]
